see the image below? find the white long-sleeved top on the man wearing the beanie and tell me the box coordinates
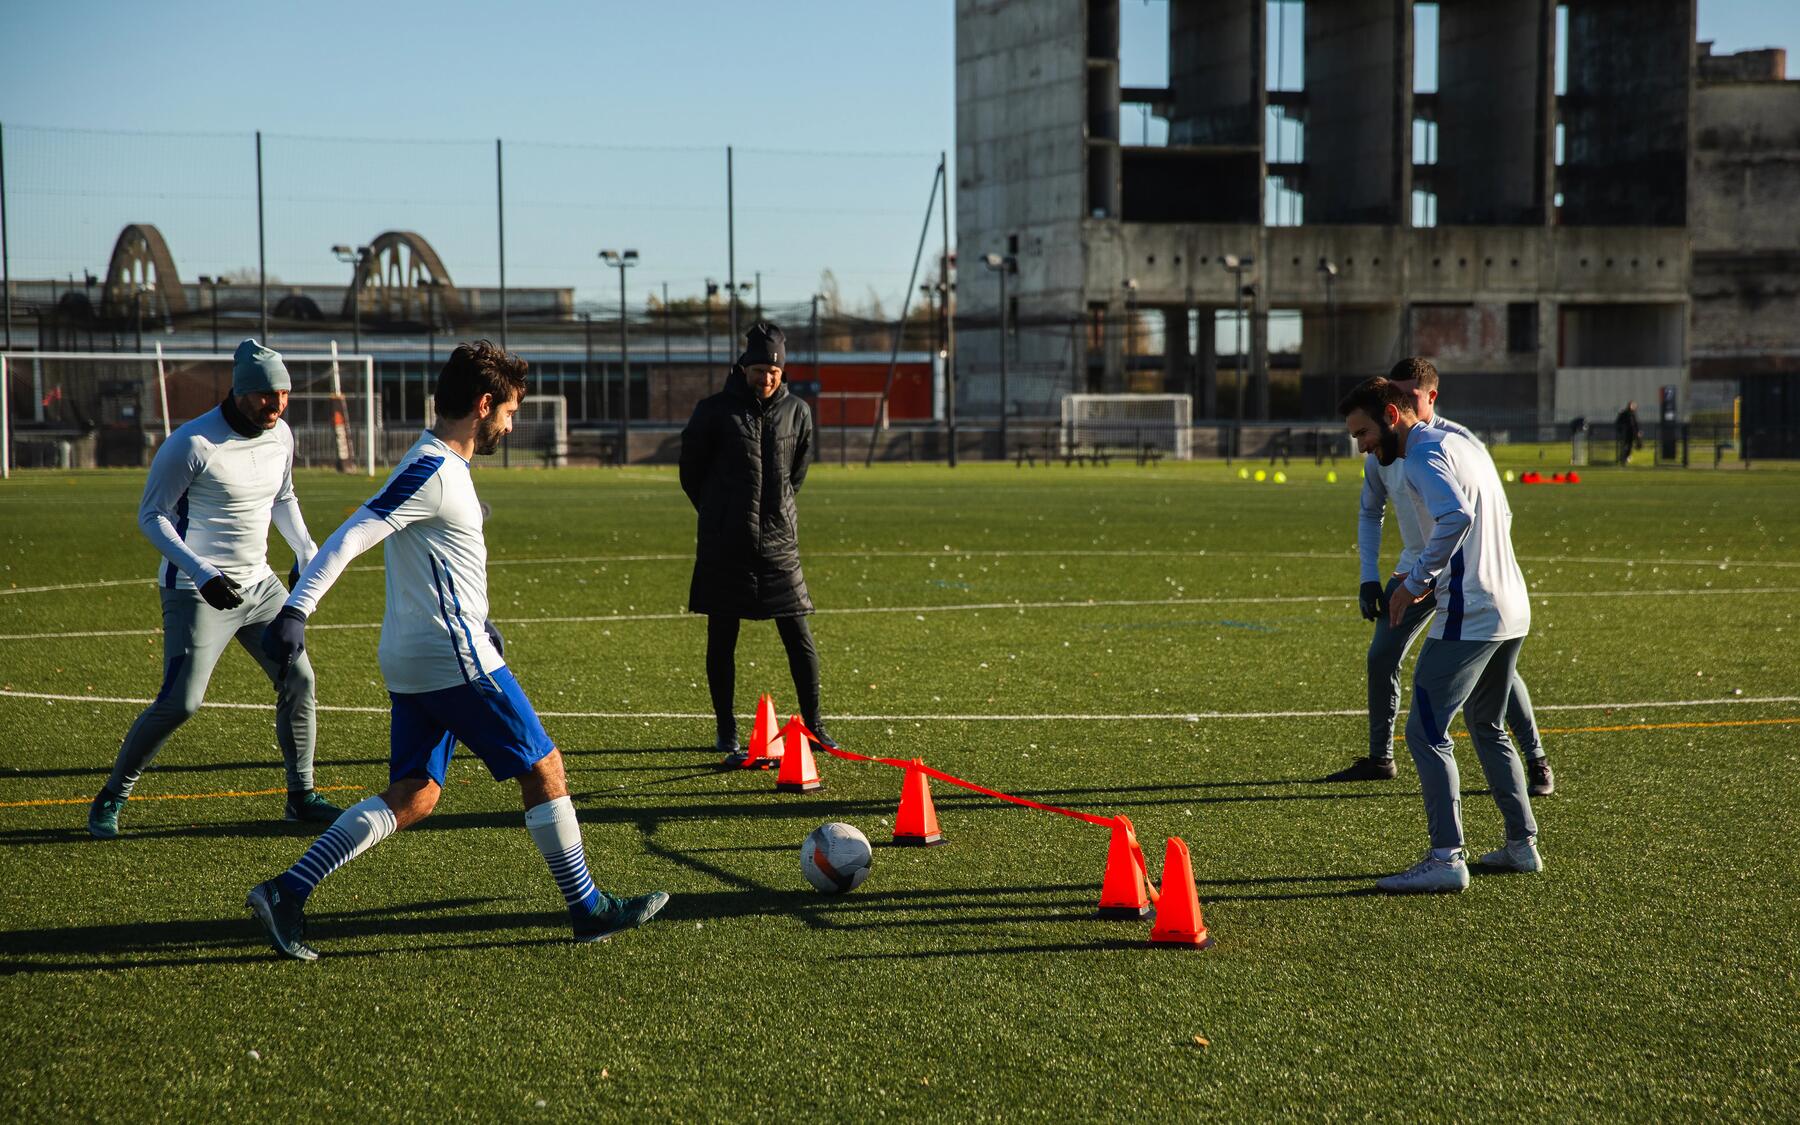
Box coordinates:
[137,407,317,590]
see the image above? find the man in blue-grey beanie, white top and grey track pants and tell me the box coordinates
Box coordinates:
[88,340,338,839]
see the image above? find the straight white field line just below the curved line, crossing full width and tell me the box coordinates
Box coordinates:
[0,587,1800,641]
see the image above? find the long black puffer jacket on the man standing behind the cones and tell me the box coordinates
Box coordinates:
[680,367,812,617]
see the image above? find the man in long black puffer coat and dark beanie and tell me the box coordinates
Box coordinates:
[680,322,830,763]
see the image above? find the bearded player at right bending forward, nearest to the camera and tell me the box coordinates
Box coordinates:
[1337,378,1543,891]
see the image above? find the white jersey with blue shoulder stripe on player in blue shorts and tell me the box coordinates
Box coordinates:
[288,430,506,695]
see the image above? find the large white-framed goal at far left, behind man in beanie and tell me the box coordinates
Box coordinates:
[0,351,387,473]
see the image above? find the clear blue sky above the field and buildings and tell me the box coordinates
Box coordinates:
[0,0,1800,313]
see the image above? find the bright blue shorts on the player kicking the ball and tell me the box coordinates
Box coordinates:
[387,666,556,785]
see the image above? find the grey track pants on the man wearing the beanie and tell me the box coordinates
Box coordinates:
[106,574,317,796]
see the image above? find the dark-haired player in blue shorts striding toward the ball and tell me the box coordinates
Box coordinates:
[247,340,670,961]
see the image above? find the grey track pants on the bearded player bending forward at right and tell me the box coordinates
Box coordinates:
[1406,637,1537,848]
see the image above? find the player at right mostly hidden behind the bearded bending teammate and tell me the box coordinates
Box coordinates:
[1325,356,1555,797]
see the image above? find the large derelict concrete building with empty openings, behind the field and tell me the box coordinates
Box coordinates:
[956,0,1771,425]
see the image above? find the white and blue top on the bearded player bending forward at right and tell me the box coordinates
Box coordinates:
[1399,427,1532,641]
